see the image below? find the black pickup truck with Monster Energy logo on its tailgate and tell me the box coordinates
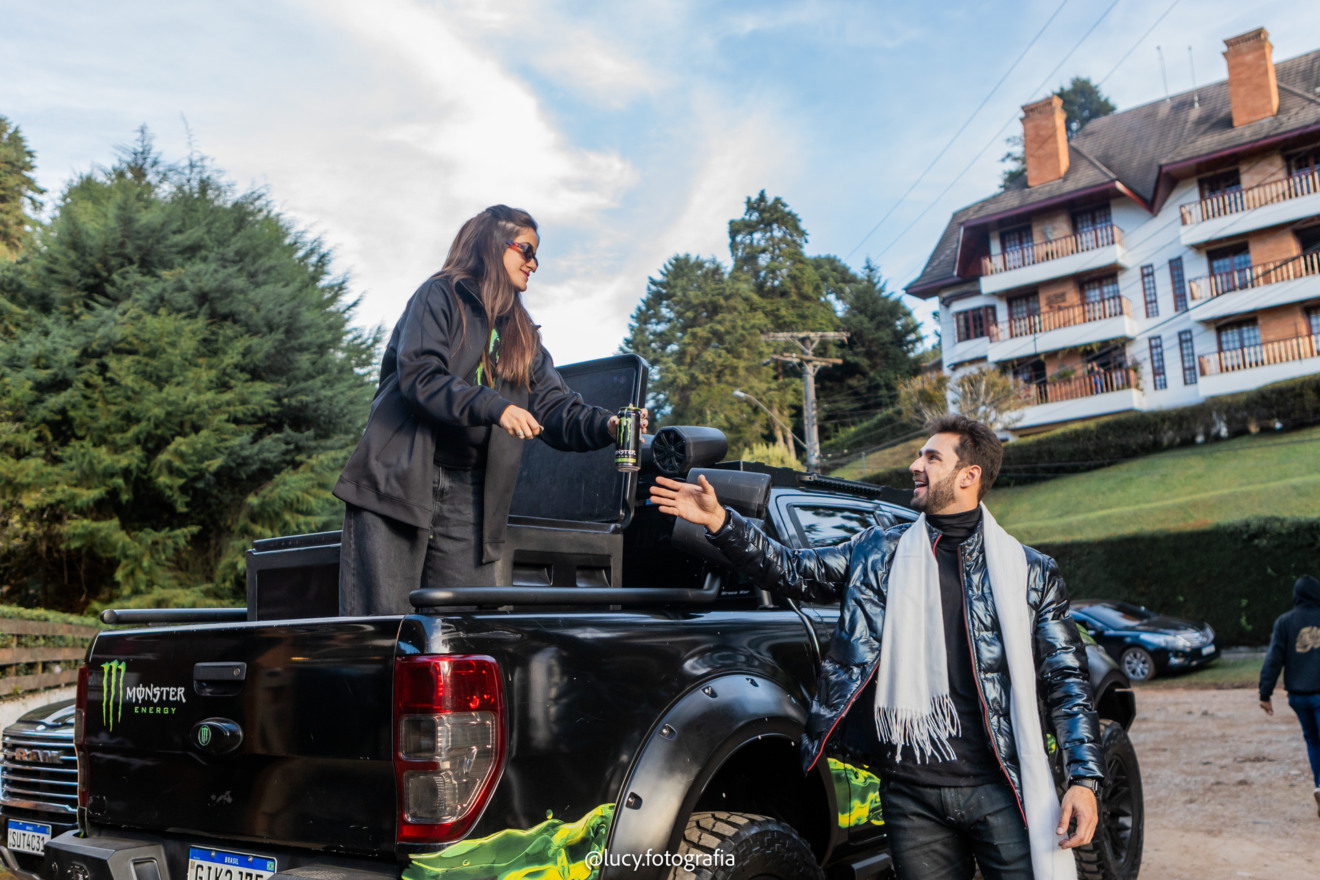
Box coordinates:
[42,356,1142,880]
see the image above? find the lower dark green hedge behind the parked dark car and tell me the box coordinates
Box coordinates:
[1038,517,1320,646]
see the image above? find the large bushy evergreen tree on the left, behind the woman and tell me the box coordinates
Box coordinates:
[0,131,378,611]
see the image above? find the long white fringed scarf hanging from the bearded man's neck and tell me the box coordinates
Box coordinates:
[875,504,1077,880]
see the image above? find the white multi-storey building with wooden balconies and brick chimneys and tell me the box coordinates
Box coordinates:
[907,29,1320,435]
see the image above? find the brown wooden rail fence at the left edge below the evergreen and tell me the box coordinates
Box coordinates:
[0,617,99,697]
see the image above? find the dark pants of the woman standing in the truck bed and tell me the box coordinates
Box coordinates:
[339,467,496,616]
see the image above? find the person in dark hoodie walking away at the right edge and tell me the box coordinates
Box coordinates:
[1261,574,1320,814]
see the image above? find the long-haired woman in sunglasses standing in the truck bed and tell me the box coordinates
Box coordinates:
[334,204,647,616]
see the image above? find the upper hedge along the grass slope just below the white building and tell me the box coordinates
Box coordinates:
[862,375,1320,487]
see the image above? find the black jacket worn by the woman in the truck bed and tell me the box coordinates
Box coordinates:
[334,278,614,562]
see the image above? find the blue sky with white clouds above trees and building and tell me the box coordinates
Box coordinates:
[0,0,1320,363]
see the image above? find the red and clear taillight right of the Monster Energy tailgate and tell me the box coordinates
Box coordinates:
[393,654,504,843]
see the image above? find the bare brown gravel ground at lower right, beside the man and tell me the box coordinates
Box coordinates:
[1130,687,1320,880]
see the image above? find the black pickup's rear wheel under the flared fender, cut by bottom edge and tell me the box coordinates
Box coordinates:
[669,813,825,880]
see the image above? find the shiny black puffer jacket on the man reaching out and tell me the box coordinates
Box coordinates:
[708,509,1105,798]
